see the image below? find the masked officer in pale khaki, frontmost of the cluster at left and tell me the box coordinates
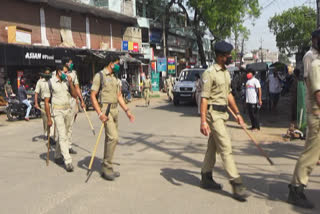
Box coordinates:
[44,66,77,172]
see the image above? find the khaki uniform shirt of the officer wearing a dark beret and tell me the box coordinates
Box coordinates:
[201,64,231,105]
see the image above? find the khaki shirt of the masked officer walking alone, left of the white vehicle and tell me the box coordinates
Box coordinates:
[91,69,121,104]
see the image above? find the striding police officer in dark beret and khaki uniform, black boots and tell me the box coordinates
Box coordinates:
[200,41,249,201]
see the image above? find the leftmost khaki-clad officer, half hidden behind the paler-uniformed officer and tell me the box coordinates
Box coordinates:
[34,68,55,140]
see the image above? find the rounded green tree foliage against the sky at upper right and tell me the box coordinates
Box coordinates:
[268,6,317,55]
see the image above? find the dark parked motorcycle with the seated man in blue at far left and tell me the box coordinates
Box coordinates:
[6,96,41,121]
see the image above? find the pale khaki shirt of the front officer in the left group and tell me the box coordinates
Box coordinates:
[44,76,71,107]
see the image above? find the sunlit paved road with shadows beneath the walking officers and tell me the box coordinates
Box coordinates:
[0,97,320,214]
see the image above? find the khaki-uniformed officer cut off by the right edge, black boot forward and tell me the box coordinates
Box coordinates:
[288,30,320,209]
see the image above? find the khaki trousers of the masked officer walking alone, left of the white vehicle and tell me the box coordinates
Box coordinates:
[102,104,119,173]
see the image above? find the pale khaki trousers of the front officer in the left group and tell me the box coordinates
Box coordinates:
[53,108,73,164]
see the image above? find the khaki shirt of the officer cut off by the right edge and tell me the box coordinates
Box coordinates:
[306,58,320,115]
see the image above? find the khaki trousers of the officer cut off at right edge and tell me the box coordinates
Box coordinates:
[291,114,320,186]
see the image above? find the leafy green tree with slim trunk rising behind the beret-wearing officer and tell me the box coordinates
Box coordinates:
[179,0,260,64]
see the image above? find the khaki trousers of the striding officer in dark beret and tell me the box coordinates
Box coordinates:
[201,110,240,180]
